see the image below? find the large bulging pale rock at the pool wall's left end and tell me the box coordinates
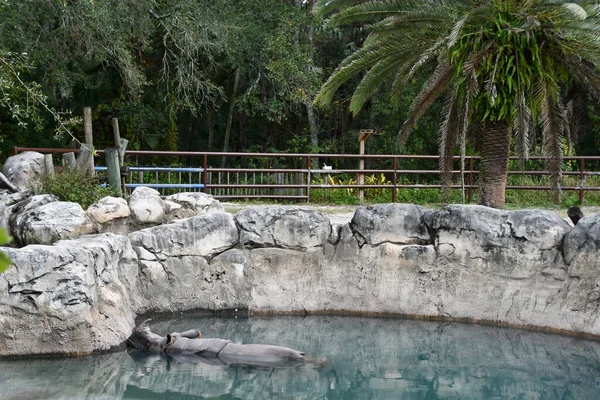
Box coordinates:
[0,234,139,356]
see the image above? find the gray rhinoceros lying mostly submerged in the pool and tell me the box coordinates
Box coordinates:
[127,320,306,367]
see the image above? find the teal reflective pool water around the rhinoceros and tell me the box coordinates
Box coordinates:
[0,316,600,400]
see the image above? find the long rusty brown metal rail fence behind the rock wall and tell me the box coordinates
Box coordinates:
[14,147,600,204]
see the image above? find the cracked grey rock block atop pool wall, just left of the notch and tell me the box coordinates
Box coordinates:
[235,207,331,249]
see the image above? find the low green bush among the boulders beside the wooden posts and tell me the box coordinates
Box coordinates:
[38,169,114,210]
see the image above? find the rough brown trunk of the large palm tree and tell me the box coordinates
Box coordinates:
[477,121,510,208]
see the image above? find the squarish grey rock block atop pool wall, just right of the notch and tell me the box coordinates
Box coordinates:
[350,204,431,246]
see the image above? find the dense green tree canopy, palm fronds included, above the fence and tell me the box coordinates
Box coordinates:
[0,0,600,206]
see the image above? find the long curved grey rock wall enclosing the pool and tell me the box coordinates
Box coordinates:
[0,204,600,355]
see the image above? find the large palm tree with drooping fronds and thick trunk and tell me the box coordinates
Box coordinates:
[315,0,600,207]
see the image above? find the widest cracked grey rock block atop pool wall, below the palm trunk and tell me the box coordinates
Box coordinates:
[424,205,572,278]
